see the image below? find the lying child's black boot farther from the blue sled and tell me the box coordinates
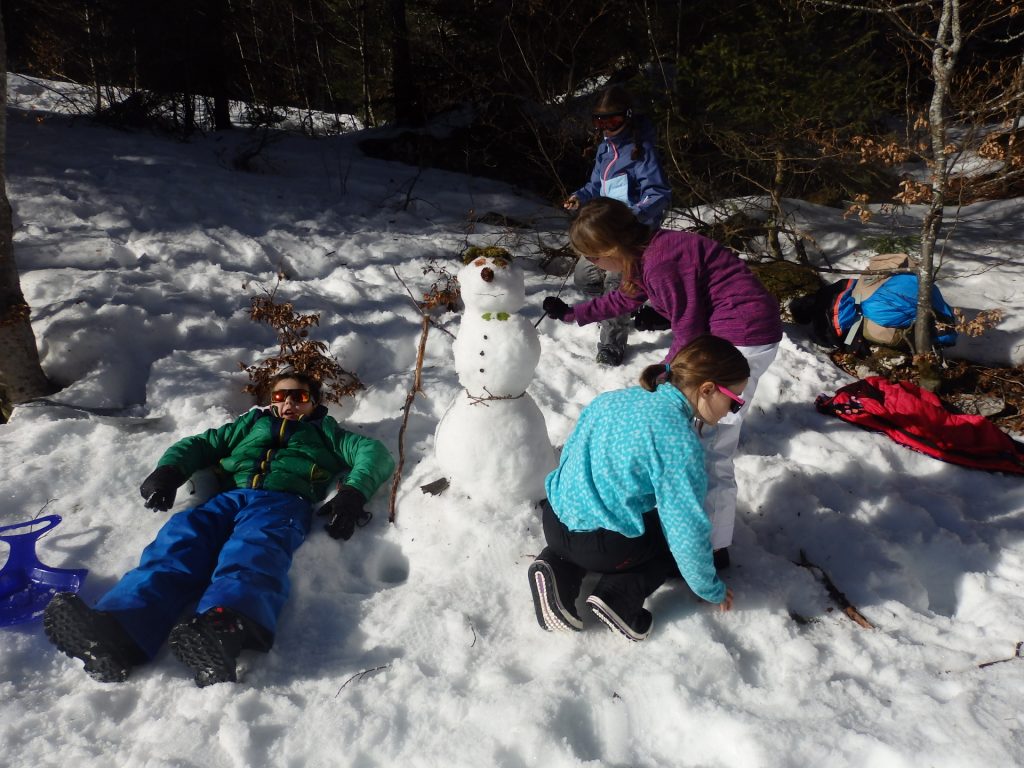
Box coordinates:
[168,605,254,688]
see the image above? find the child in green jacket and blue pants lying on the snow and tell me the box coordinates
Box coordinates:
[43,370,394,687]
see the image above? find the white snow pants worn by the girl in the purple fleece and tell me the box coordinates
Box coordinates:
[702,343,778,549]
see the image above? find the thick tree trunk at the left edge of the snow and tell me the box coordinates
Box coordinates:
[0,13,54,421]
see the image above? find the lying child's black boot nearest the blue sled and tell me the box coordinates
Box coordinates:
[43,592,145,683]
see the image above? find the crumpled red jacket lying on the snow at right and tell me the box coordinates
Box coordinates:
[814,376,1024,474]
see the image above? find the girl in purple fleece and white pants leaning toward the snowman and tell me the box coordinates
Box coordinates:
[544,198,782,567]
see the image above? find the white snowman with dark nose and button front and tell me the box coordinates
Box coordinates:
[434,249,556,504]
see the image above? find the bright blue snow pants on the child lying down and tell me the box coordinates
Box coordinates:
[95,488,312,658]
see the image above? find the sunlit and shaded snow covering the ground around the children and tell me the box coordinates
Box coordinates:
[6,76,1024,768]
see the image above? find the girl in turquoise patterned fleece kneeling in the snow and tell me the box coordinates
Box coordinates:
[529,336,750,641]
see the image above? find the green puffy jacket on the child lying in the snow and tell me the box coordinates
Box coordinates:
[158,406,394,503]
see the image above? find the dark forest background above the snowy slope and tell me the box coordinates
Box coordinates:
[2,0,1022,217]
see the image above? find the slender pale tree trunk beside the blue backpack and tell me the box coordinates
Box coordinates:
[913,0,963,354]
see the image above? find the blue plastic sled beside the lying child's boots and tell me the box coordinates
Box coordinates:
[0,515,89,627]
